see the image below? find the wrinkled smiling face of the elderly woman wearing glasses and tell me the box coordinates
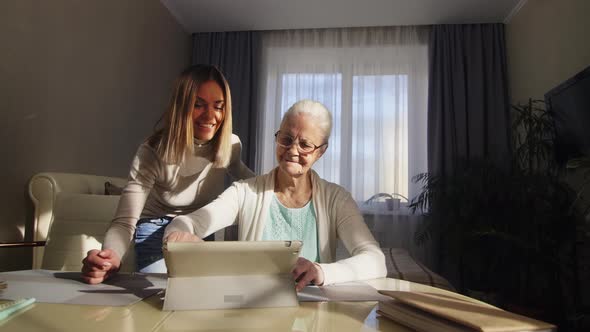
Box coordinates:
[275,113,324,177]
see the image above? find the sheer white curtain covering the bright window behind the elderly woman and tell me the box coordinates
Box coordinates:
[256,27,429,202]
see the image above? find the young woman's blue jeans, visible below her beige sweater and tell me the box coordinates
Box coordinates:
[135,217,172,273]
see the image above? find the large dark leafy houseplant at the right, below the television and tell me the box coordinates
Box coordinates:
[410,100,575,321]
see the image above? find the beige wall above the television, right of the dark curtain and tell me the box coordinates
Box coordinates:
[506,0,590,103]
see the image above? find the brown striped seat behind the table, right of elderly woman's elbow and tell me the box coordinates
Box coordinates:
[381,248,455,291]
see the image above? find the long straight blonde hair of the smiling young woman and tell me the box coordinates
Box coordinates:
[147,65,232,167]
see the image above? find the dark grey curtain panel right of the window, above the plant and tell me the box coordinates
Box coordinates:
[428,24,510,174]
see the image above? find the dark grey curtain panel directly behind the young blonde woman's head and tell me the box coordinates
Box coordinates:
[192,31,259,170]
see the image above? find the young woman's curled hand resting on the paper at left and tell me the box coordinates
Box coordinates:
[82,249,121,284]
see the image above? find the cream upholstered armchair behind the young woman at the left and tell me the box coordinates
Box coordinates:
[29,173,135,271]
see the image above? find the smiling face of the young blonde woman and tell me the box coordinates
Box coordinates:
[192,81,225,141]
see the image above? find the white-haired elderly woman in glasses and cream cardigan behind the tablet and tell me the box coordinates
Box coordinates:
[164,100,386,291]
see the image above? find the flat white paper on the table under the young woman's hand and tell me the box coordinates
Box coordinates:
[0,270,166,306]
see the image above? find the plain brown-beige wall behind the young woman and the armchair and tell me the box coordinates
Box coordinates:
[0,0,191,270]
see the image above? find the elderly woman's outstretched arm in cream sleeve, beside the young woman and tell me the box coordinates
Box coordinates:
[164,183,241,239]
